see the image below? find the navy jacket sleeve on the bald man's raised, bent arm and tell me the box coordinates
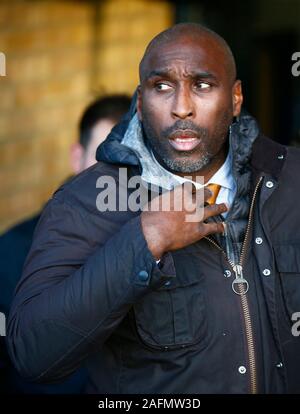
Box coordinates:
[7,194,175,382]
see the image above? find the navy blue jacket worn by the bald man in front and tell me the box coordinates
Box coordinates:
[7,111,300,393]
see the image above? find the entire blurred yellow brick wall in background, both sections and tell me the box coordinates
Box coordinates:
[0,0,173,231]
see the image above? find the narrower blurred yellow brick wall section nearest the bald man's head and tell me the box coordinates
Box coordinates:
[94,0,173,93]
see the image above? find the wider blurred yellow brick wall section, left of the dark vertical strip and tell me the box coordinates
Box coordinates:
[0,1,93,229]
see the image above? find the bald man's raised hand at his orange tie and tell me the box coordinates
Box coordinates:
[141,186,228,259]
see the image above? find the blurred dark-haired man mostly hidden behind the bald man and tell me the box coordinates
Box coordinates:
[0,94,130,393]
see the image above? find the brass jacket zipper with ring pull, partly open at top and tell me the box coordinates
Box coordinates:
[205,177,263,394]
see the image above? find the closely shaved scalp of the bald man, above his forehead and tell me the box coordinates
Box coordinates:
[139,23,236,84]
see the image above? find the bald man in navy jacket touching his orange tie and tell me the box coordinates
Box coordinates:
[8,24,300,393]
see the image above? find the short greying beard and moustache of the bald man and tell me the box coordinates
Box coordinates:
[143,112,232,174]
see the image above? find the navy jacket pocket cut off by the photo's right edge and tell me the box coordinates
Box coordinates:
[274,242,300,317]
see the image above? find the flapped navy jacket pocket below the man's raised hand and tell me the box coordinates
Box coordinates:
[133,262,207,350]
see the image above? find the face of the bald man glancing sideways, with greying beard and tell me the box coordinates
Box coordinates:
[138,37,242,173]
